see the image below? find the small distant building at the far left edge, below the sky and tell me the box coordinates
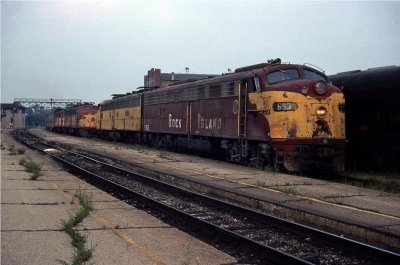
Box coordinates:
[0,103,26,129]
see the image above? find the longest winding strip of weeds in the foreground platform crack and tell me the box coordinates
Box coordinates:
[57,190,93,265]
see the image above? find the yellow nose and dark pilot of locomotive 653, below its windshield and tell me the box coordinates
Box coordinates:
[245,76,345,171]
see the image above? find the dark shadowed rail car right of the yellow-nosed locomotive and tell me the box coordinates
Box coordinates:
[329,66,400,171]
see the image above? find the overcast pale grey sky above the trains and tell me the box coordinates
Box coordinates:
[1,0,400,103]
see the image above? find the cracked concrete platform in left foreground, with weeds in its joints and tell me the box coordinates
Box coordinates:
[1,131,237,265]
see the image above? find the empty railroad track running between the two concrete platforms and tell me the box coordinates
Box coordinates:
[16,132,400,264]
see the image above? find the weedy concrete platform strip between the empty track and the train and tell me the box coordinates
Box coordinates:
[28,129,400,251]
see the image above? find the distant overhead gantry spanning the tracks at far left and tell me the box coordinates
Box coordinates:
[14,98,82,109]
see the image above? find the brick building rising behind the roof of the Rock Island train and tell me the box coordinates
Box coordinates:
[144,68,217,87]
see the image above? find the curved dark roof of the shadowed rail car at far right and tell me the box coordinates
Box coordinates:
[328,66,400,91]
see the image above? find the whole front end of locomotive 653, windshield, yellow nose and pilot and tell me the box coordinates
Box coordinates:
[244,61,346,171]
